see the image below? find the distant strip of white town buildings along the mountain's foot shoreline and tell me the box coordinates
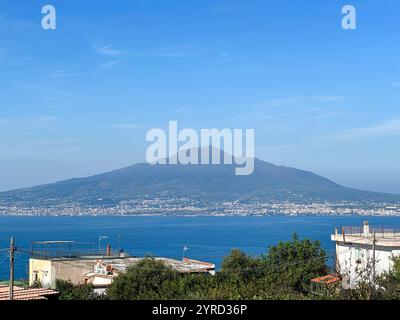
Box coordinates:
[0,197,400,216]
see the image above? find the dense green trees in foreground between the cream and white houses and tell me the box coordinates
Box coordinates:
[107,236,327,299]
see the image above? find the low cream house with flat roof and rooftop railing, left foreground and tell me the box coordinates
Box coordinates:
[29,241,215,288]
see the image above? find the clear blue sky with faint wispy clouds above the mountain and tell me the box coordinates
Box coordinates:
[0,0,400,193]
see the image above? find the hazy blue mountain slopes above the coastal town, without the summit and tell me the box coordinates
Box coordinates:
[0,148,400,205]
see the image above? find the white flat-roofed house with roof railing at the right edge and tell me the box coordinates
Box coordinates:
[331,221,400,288]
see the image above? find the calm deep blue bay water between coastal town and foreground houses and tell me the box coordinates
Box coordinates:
[0,216,400,279]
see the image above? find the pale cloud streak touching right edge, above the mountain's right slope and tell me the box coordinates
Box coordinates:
[333,119,400,139]
